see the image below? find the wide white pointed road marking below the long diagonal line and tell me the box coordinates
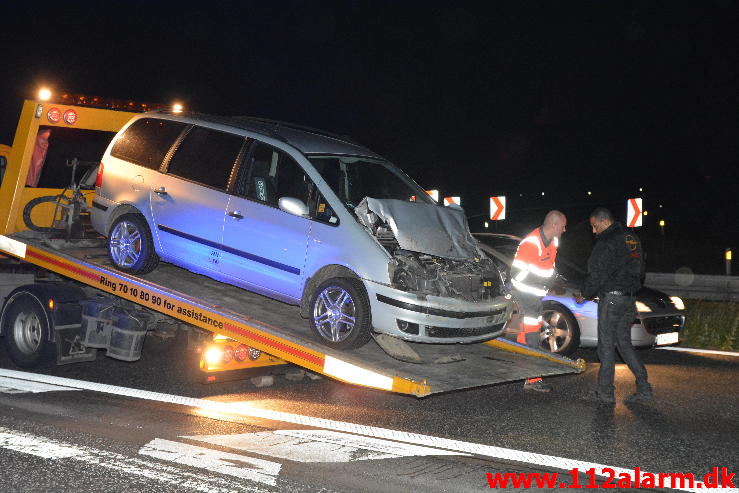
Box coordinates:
[186,430,467,462]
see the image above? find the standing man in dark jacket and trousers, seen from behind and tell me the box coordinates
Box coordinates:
[577,207,652,404]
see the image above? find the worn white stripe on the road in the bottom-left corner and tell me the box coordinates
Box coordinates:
[0,427,267,493]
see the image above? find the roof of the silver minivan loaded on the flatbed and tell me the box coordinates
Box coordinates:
[146,111,383,159]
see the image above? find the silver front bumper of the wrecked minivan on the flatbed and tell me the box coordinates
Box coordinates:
[365,280,513,344]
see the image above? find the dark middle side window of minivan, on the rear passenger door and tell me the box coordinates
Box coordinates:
[167,127,244,190]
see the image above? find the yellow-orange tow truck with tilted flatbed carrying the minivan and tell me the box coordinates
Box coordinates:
[0,94,585,397]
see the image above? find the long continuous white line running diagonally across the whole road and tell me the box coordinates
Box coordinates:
[0,369,739,493]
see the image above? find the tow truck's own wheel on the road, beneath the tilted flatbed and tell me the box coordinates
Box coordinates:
[3,293,56,369]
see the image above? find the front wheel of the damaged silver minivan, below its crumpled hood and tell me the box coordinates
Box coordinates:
[310,277,372,349]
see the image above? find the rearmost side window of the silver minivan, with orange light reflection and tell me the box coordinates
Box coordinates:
[110,118,185,169]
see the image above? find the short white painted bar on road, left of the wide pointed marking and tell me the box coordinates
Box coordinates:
[139,438,282,486]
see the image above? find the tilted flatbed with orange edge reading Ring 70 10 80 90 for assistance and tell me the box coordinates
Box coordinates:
[0,231,584,397]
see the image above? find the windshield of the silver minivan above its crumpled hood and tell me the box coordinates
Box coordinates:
[308,156,435,211]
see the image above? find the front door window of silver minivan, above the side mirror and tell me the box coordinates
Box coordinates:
[234,141,312,207]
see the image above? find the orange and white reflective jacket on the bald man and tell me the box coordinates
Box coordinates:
[511,228,559,296]
